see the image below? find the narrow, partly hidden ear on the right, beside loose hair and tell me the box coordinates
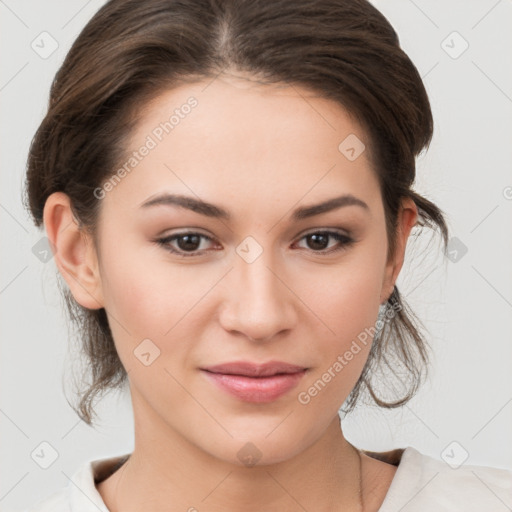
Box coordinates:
[380,197,418,304]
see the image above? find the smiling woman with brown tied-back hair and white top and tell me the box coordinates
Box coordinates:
[22,0,512,512]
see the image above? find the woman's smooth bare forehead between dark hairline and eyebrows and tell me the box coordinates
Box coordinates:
[102,70,378,218]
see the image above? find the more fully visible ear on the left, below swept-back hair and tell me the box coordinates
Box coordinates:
[43,192,104,309]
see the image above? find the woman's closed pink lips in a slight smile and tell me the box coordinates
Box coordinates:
[201,361,308,403]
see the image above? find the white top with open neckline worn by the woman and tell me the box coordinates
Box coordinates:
[24,446,512,512]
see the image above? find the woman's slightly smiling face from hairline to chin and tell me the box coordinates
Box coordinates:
[54,76,414,464]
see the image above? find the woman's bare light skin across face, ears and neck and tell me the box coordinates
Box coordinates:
[44,73,418,512]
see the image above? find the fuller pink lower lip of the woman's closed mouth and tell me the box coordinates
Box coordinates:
[203,370,306,403]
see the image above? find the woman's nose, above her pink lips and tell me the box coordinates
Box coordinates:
[220,247,298,342]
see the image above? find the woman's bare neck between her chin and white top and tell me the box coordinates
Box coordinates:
[98,411,362,512]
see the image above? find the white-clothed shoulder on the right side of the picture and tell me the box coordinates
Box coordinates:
[378,447,512,512]
